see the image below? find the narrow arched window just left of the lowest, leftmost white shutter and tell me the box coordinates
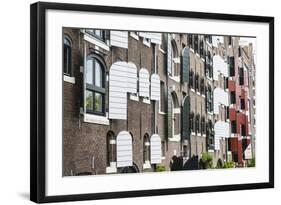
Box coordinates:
[106,131,116,167]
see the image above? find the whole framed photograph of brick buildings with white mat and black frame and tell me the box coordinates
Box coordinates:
[30,2,274,203]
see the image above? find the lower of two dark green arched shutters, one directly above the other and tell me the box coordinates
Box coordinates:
[182,96,190,139]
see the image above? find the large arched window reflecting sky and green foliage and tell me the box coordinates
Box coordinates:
[85,55,105,116]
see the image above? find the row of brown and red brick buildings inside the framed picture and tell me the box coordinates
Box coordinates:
[63,28,255,176]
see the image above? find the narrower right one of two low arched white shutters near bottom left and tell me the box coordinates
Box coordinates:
[150,134,162,164]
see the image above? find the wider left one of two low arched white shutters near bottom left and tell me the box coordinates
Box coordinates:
[116,131,133,167]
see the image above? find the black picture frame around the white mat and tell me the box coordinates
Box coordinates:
[30,2,274,203]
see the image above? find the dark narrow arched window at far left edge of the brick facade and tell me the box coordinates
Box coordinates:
[63,36,72,76]
